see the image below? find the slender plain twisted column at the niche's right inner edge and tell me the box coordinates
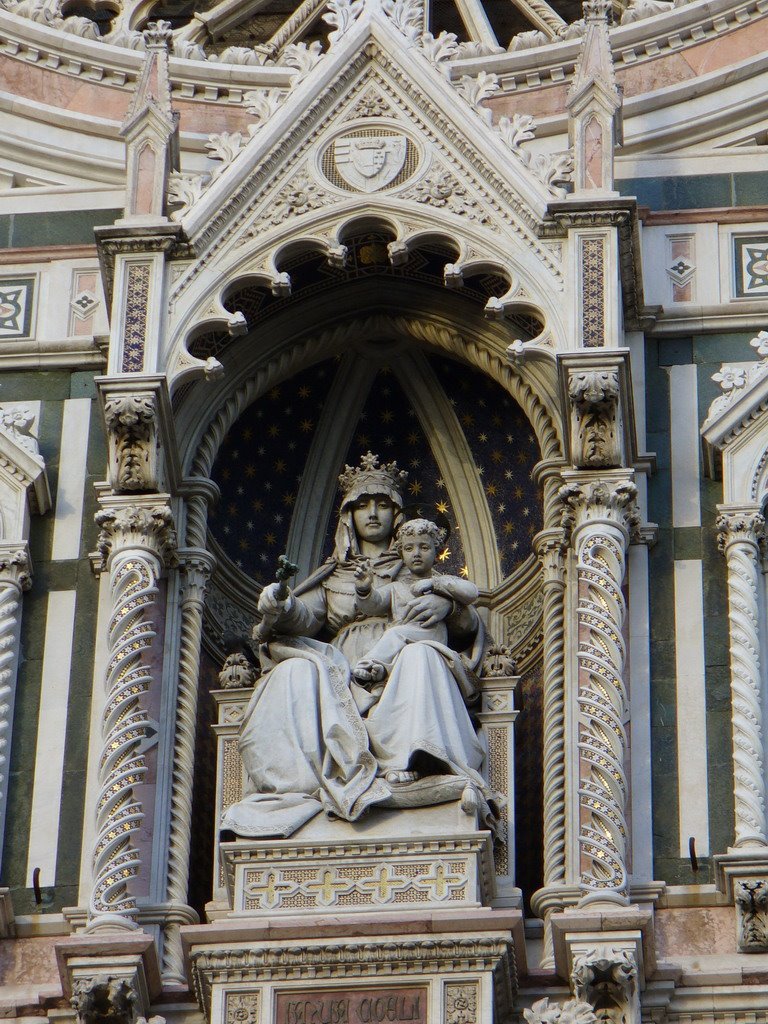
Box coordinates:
[535,529,565,968]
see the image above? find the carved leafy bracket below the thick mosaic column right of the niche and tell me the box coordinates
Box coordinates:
[570,944,640,1024]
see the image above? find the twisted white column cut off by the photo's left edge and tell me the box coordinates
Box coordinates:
[0,543,32,856]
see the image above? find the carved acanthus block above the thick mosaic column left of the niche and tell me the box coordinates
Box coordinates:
[104,392,158,492]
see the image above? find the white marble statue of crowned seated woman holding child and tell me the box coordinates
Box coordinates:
[221,453,493,838]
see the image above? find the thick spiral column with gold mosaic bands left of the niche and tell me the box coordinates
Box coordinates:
[88,506,173,930]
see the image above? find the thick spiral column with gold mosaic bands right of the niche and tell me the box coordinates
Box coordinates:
[561,480,639,903]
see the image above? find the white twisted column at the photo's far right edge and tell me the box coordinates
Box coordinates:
[717,511,768,847]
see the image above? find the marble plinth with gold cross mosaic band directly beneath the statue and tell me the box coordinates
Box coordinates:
[220,801,495,919]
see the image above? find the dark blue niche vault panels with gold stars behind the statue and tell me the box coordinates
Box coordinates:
[211,355,541,584]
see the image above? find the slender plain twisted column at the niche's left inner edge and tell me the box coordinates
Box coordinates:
[163,544,214,984]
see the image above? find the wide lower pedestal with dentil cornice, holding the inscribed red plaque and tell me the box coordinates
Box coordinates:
[181,910,524,1024]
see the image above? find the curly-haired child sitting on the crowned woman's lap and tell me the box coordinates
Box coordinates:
[352,519,478,686]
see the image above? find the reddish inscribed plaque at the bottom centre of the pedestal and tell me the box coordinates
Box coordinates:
[274,986,427,1024]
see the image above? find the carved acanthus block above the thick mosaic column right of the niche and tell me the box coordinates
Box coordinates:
[568,367,622,468]
